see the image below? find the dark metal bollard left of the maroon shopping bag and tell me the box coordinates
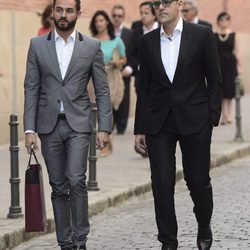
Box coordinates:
[7,114,23,219]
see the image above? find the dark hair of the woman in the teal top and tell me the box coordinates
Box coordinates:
[89,10,115,40]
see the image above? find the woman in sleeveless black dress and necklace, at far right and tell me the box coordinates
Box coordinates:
[215,12,241,125]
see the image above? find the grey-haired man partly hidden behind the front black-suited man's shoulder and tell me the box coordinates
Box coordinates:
[181,0,212,29]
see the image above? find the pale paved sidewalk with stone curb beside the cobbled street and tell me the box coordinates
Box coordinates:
[0,94,250,250]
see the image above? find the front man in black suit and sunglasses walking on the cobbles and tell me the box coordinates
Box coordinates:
[134,0,222,250]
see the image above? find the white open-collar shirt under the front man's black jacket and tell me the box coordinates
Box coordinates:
[160,18,183,82]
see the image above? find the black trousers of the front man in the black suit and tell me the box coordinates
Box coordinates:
[146,111,213,247]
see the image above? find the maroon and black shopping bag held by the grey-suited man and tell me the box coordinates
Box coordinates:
[25,149,47,232]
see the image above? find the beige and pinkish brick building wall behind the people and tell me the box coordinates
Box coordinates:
[0,0,250,144]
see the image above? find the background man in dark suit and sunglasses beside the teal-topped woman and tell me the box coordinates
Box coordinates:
[112,4,133,134]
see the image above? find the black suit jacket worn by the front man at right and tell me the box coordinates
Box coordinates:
[134,22,222,135]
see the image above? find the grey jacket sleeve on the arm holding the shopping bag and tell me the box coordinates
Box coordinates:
[23,39,40,131]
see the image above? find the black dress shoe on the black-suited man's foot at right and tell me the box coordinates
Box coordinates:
[197,226,213,250]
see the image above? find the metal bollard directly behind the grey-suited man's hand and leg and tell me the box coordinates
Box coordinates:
[88,103,99,191]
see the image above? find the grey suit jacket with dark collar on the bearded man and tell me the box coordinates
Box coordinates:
[24,32,112,134]
